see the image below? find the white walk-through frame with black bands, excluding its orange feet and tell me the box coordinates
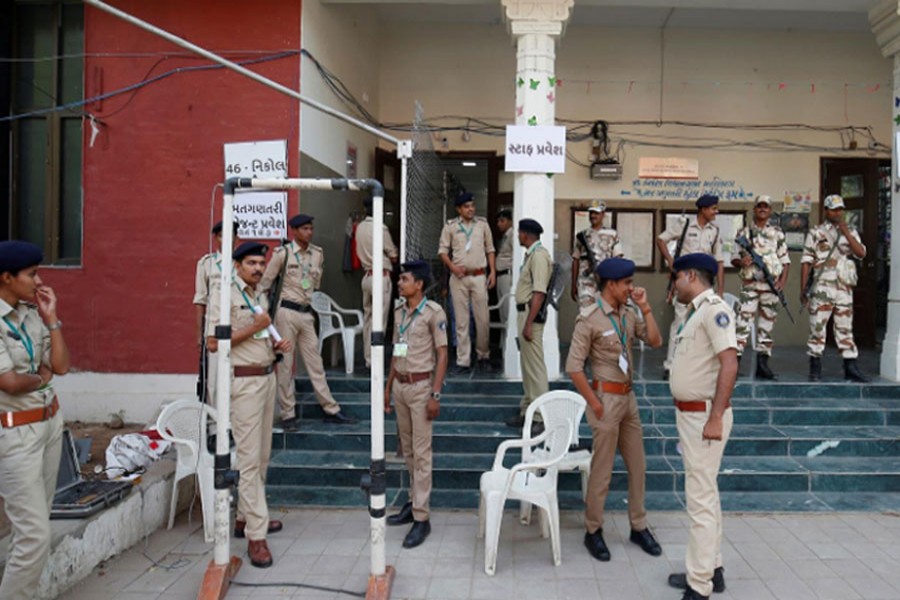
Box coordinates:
[214,177,386,578]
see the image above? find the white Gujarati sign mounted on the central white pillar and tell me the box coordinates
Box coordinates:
[506,125,566,173]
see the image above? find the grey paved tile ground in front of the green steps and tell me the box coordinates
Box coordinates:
[62,509,900,600]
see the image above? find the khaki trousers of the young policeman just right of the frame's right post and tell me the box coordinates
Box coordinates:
[391,379,432,521]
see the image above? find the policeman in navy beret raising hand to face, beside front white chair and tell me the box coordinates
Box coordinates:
[566,258,662,561]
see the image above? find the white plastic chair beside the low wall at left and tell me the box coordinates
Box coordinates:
[156,398,217,543]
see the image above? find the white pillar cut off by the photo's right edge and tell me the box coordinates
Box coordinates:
[869,0,900,381]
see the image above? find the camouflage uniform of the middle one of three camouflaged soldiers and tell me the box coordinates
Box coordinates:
[731,224,791,356]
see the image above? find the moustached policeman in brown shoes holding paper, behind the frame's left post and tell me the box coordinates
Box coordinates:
[206,242,292,568]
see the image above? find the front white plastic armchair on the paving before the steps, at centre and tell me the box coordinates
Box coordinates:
[478,390,585,575]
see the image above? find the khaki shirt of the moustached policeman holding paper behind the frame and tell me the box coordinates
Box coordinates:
[206,277,275,367]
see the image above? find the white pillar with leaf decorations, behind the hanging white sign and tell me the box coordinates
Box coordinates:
[503,0,574,380]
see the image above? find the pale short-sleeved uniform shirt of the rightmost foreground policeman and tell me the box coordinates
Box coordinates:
[669,289,737,400]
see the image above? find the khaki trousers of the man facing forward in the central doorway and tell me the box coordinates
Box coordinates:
[450,275,491,367]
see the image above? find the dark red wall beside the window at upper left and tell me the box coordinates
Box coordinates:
[42,0,300,373]
